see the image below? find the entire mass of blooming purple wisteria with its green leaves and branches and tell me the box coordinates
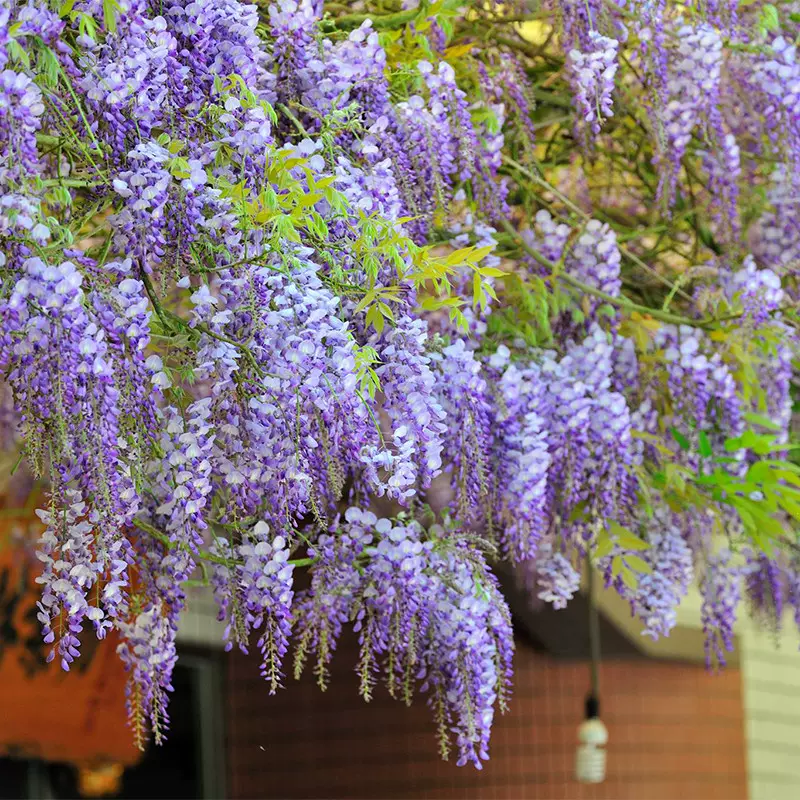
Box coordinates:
[0,0,800,767]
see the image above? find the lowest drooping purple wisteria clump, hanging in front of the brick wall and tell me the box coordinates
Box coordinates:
[297,508,513,767]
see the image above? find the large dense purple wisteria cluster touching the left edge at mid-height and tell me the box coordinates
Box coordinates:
[0,258,138,549]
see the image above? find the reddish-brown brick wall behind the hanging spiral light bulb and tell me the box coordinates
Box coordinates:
[226,641,747,800]
